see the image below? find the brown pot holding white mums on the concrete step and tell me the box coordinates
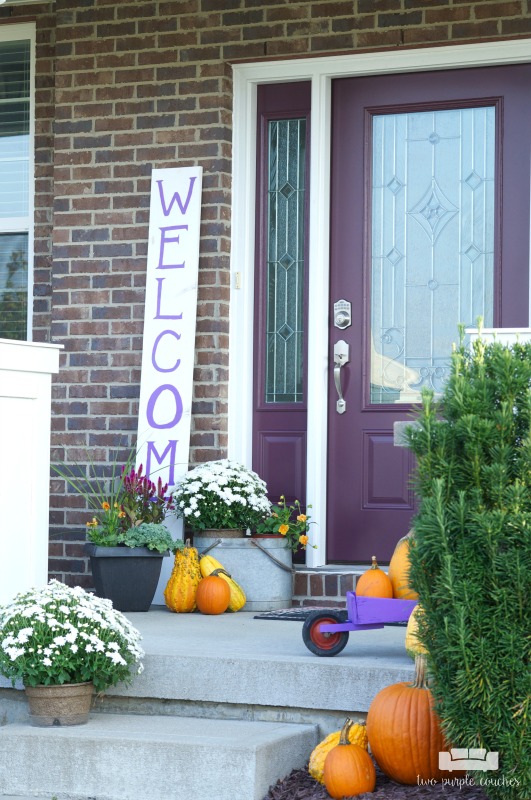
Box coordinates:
[25,681,94,728]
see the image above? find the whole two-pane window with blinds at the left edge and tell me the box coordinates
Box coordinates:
[0,26,33,340]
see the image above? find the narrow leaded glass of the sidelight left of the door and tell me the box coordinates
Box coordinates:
[265,119,306,403]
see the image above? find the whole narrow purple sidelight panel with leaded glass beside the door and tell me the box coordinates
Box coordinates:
[253,81,311,516]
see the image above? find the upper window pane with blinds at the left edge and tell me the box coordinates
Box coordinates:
[0,41,30,218]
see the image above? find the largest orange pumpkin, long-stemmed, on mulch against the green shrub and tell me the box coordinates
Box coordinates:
[367,655,448,785]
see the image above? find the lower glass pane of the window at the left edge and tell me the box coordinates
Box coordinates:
[0,233,28,340]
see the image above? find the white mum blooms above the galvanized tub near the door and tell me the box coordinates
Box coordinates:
[173,459,271,531]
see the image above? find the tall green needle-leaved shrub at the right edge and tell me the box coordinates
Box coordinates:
[408,332,531,800]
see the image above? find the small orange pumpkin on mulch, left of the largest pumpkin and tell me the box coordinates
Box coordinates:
[324,719,376,798]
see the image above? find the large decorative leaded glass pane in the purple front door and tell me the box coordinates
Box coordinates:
[370,106,495,403]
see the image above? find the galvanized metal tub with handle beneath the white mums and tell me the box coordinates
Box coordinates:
[193,530,293,611]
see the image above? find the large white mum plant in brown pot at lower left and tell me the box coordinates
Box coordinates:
[0,581,144,692]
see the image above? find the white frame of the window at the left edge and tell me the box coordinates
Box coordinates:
[0,23,35,342]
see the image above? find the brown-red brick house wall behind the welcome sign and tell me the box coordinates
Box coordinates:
[0,0,531,586]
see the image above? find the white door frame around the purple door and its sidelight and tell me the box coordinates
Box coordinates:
[228,38,531,567]
